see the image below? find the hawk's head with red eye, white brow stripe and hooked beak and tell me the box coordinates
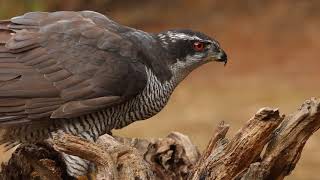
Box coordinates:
[157,30,227,81]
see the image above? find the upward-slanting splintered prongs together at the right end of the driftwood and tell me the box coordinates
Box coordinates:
[189,98,320,180]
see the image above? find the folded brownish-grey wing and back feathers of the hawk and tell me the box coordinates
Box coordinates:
[0,11,147,127]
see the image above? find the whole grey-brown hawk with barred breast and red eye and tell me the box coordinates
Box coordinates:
[0,11,227,176]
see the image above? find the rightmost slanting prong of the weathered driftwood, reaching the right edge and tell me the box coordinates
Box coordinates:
[241,98,320,179]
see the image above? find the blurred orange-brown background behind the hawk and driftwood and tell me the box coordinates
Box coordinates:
[0,0,320,180]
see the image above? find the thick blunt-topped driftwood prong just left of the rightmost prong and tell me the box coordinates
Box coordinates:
[190,108,283,180]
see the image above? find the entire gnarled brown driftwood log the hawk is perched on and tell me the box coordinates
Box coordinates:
[0,98,320,180]
